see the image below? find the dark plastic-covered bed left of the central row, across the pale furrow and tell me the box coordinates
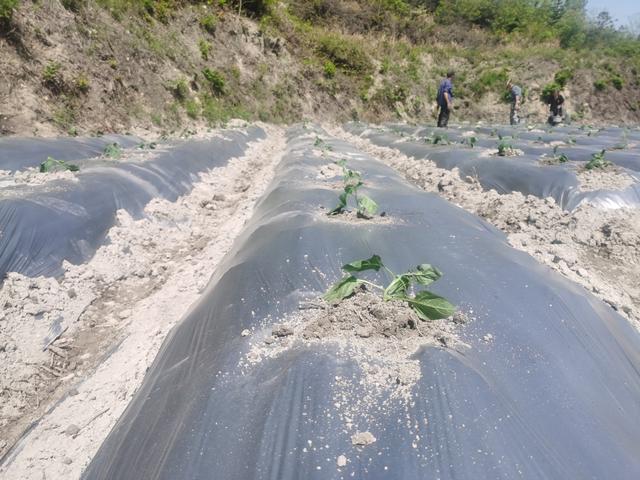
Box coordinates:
[0,128,264,281]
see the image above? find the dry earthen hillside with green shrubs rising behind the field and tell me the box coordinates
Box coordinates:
[0,0,640,135]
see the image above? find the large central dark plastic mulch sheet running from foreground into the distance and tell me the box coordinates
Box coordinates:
[83,129,640,480]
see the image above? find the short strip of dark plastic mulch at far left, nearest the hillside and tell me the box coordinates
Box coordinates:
[0,135,141,172]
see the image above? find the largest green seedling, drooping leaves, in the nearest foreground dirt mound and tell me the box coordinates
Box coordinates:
[323,255,456,320]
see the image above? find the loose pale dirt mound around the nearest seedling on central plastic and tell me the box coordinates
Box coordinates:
[246,290,466,403]
